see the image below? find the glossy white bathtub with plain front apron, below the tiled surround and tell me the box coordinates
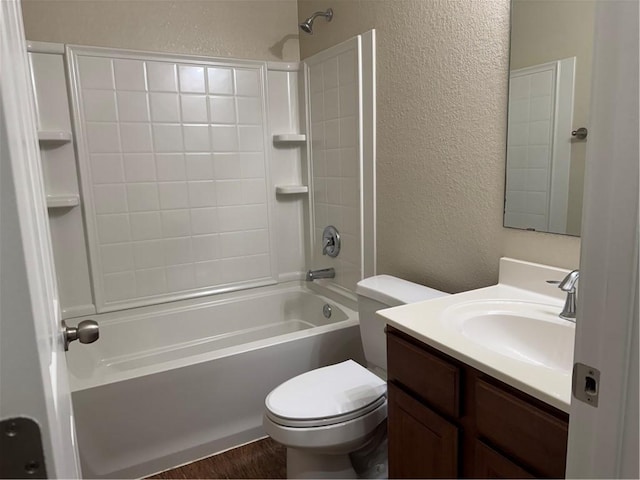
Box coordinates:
[67,283,363,478]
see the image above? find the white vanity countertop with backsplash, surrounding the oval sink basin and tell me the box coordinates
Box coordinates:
[377,258,575,413]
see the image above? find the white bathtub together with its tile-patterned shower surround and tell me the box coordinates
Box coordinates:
[29,15,375,478]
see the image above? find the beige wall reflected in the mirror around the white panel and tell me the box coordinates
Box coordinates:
[510,0,595,235]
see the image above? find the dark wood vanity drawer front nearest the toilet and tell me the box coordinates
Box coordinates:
[387,333,460,418]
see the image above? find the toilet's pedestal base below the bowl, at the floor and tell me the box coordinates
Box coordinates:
[287,448,358,478]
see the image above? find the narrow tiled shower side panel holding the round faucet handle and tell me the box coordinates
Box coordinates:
[305,37,363,291]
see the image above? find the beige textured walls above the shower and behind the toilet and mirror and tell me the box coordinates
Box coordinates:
[23,0,580,292]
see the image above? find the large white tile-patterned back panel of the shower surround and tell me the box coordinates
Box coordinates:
[67,47,276,312]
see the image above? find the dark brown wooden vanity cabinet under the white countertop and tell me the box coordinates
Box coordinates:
[387,326,569,478]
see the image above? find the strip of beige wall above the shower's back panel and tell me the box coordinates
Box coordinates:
[22,0,299,61]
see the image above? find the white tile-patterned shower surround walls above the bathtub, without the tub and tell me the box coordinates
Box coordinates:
[30,40,375,318]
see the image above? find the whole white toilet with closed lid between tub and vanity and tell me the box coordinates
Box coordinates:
[263,275,447,478]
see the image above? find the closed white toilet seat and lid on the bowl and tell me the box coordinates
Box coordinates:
[265,360,387,427]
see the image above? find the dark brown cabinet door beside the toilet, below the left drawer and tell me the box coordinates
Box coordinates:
[388,383,458,478]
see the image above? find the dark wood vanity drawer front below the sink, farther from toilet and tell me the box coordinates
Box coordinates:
[475,379,568,478]
